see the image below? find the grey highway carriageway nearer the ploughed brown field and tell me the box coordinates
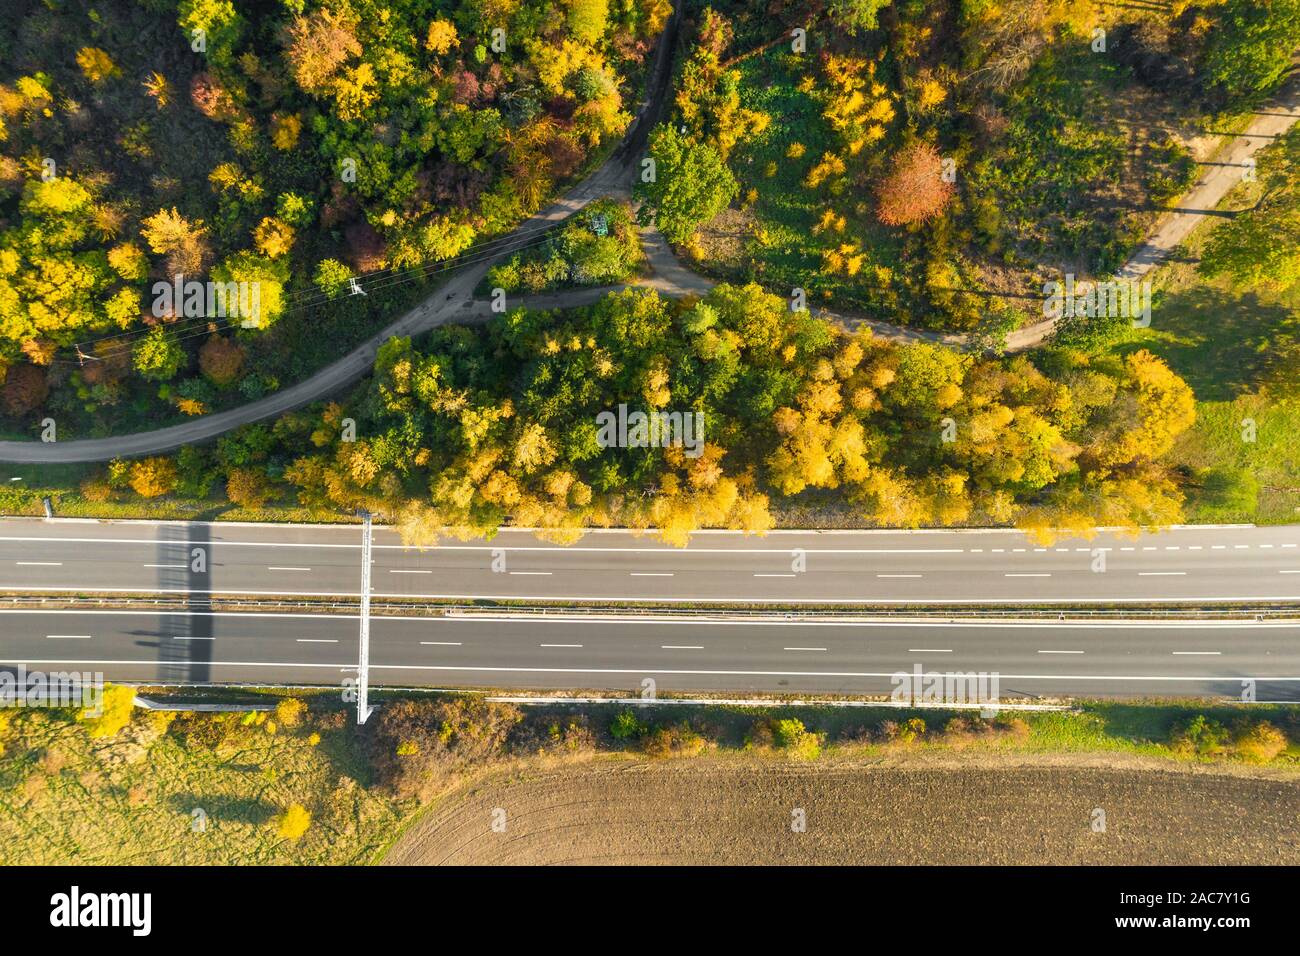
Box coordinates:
[0,610,1300,700]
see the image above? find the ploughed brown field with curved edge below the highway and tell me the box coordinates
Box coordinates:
[385,752,1300,865]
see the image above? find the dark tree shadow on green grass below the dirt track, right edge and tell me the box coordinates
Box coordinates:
[1122,285,1292,402]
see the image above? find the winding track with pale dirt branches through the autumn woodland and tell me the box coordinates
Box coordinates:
[0,54,1300,464]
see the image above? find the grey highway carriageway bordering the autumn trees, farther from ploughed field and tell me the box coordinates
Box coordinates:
[0,519,1300,606]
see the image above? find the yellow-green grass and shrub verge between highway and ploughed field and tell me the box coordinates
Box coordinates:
[0,685,1300,865]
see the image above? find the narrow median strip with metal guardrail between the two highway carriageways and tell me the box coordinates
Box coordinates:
[0,594,1300,622]
